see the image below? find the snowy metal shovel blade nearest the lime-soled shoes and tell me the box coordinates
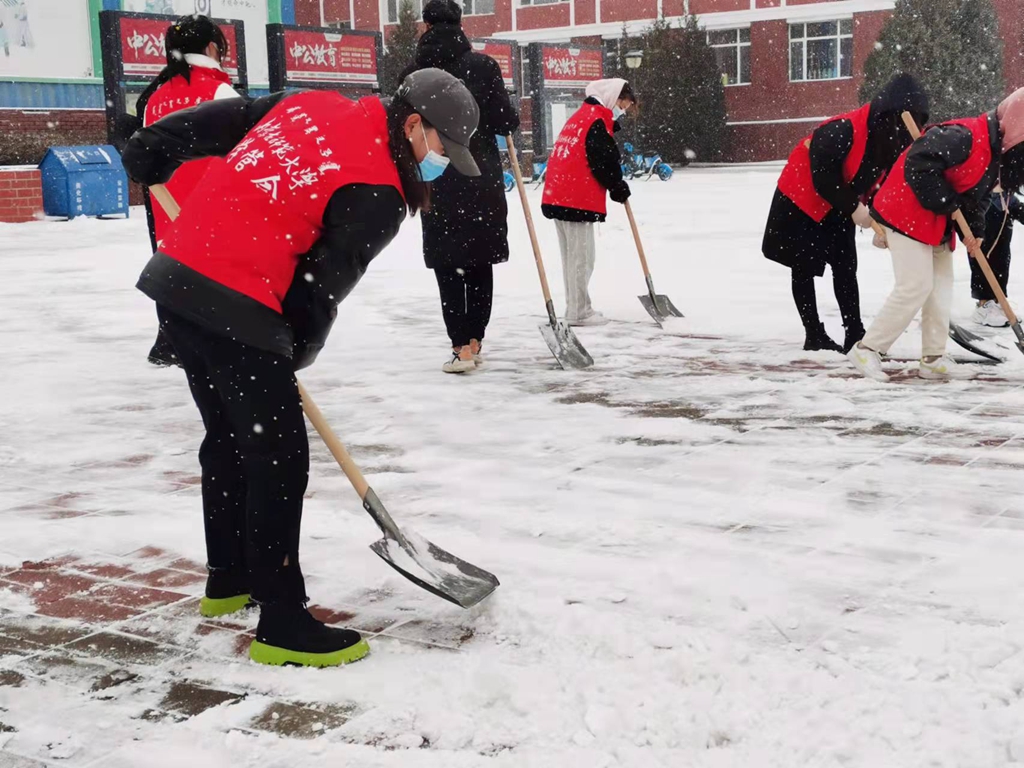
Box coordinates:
[370,530,501,608]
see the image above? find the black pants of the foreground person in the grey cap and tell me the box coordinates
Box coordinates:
[157,307,309,603]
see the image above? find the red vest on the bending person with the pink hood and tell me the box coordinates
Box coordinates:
[872,115,992,246]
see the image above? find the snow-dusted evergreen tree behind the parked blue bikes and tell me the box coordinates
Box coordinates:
[633,16,726,163]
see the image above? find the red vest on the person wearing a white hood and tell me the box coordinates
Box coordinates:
[543,103,615,215]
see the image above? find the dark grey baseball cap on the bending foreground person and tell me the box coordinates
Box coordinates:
[397,69,480,176]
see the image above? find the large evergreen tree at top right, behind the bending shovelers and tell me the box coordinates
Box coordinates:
[860,0,1004,122]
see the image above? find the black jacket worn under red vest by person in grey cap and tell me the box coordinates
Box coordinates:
[121,93,407,370]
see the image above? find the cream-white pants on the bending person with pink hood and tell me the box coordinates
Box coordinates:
[861,227,953,357]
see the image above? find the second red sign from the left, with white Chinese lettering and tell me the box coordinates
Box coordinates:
[285,27,377,85]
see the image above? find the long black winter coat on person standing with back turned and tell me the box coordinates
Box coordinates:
[402,24,519,269]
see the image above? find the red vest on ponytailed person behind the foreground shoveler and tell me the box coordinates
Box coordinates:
[144,67,231,244]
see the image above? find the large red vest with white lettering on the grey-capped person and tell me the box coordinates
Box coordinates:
[160,91,401,312]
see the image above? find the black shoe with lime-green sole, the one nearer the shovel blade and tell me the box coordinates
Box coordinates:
[249,603,370,667]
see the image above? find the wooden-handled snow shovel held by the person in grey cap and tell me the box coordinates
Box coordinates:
[150,184,500,608]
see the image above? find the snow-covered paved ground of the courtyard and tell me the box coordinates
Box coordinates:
[0,168,1024,768]
